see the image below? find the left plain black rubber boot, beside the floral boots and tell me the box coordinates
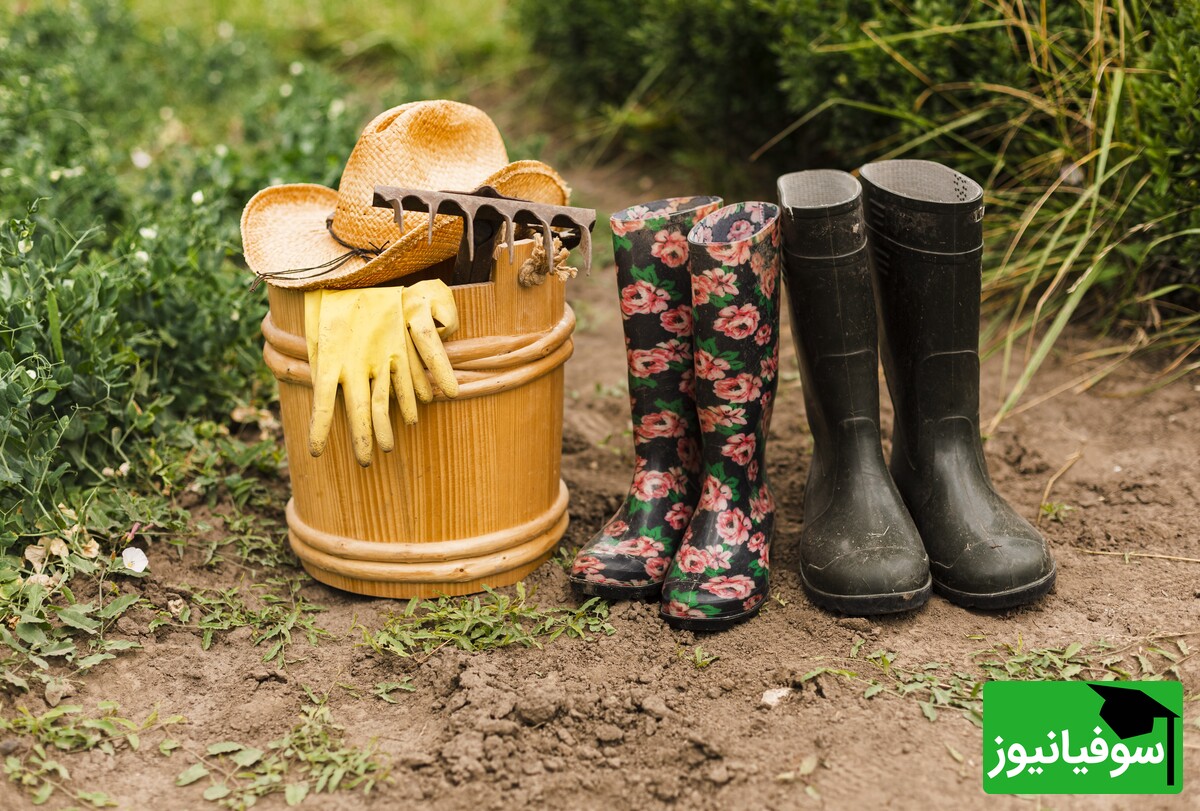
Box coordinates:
[779,169,930,614]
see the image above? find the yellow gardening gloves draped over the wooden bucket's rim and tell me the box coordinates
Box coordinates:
[305,282,458,467]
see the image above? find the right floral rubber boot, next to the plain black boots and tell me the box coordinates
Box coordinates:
[660,203,780,631]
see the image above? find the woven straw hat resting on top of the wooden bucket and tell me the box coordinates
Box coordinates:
[241,101,570,290]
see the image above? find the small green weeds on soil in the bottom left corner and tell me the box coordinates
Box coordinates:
[0,701,184,807]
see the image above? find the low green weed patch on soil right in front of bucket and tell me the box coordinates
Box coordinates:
[360,583,614,657]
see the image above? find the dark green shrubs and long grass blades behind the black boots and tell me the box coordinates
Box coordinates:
[512,0,1200,415]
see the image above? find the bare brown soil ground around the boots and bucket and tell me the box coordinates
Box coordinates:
[0,172,1200,811]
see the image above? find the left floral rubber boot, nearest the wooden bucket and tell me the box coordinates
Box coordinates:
[570,197,721,600]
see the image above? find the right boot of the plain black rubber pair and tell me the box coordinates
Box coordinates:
[862,161,1055,608]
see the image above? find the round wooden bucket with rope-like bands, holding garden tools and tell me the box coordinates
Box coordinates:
[256,241,575,597]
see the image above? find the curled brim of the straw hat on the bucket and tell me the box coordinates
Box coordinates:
[241,161,570,290]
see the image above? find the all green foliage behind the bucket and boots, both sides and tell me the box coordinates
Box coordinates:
[0,0,1200,685]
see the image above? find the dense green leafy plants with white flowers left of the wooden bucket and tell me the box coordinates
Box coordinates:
[0,0,360,690]
